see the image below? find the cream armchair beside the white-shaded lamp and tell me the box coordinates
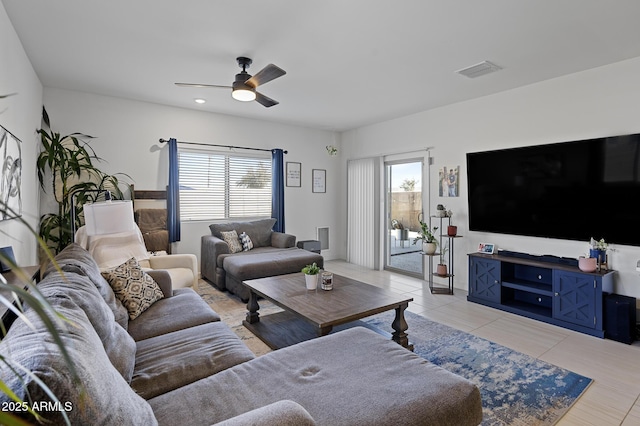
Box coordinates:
[76,226,198,289]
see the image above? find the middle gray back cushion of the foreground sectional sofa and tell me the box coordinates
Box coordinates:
[38,265,136,383]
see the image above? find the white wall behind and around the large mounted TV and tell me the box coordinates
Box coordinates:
[342,58,640,298]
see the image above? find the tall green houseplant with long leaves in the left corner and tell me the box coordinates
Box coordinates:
[36,107,129,253]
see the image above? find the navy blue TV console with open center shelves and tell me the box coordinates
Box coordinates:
[467,252,615,337]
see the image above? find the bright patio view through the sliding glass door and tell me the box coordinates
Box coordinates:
[385,160,423,276]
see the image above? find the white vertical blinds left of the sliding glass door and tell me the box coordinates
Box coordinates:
[347,158,380,269]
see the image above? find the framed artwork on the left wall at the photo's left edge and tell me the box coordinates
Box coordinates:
[0,126,22,220]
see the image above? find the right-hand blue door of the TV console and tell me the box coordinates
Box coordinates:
[553,270,598,328]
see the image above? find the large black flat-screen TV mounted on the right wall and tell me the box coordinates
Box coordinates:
[467,134,640,246]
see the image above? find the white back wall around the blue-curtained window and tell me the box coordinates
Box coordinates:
[44,88,344,259]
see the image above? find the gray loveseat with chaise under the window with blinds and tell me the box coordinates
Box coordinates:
[200,219,324,302]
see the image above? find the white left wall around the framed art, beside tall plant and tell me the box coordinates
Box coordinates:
[0,2,42,265]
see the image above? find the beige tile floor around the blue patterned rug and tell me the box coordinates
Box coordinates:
[200,261,640,426]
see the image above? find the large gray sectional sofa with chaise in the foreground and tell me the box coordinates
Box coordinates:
[0,245,482,426]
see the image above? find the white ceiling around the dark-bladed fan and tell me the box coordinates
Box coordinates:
[2,0,640,131]
